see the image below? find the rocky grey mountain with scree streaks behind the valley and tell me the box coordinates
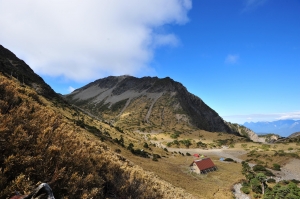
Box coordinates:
[65,76,258,141]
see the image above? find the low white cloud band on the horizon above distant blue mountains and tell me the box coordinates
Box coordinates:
[222,111,300,124]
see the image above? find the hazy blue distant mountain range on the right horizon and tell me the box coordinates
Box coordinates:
[243,120,300,137]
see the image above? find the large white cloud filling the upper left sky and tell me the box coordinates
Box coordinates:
[0,0,192,81]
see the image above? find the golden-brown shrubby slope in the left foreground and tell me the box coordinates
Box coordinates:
[0,75,193,198]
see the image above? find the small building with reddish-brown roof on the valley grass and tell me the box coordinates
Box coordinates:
[190,158,217,174]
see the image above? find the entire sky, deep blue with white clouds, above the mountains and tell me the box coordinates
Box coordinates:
[0,0,300,123]
